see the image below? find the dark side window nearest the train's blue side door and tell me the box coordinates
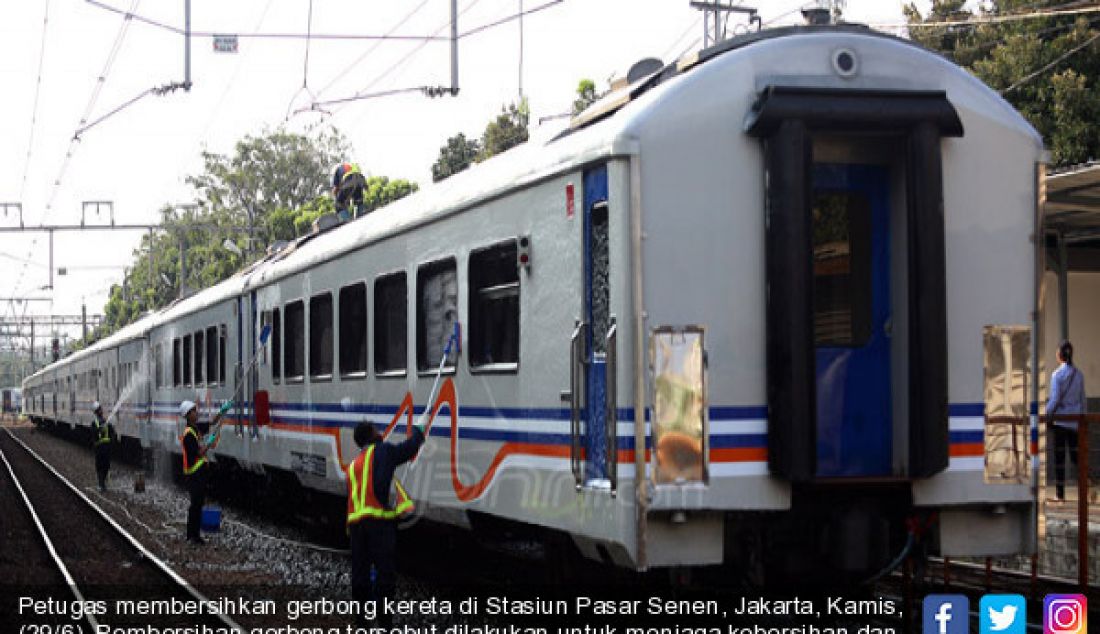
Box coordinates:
[470,240,519,370]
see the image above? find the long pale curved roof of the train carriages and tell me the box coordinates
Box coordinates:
[29,24,1042,387]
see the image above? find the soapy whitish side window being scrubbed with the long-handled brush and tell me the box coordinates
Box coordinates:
[416,259,459,372]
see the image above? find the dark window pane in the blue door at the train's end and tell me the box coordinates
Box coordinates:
[813,190,871,348]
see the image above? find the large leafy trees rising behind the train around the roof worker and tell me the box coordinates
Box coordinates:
[88,130,417,348]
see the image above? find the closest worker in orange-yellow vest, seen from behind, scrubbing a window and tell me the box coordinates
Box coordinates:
[348,422,424,627]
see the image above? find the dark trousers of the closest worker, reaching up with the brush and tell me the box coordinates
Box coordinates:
[351,520,397,627]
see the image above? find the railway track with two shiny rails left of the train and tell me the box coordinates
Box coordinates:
[0,429,244,632]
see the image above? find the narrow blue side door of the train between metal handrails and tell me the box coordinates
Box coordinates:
[582,166,611,482]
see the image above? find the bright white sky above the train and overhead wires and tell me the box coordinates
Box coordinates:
[0,0,931,356]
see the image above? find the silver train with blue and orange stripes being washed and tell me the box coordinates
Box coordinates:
[24,26,1044,580]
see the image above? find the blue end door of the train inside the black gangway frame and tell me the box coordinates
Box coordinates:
[812,163,893,478]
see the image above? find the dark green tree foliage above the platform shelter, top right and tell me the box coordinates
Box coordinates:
[904,0,1100,165]
